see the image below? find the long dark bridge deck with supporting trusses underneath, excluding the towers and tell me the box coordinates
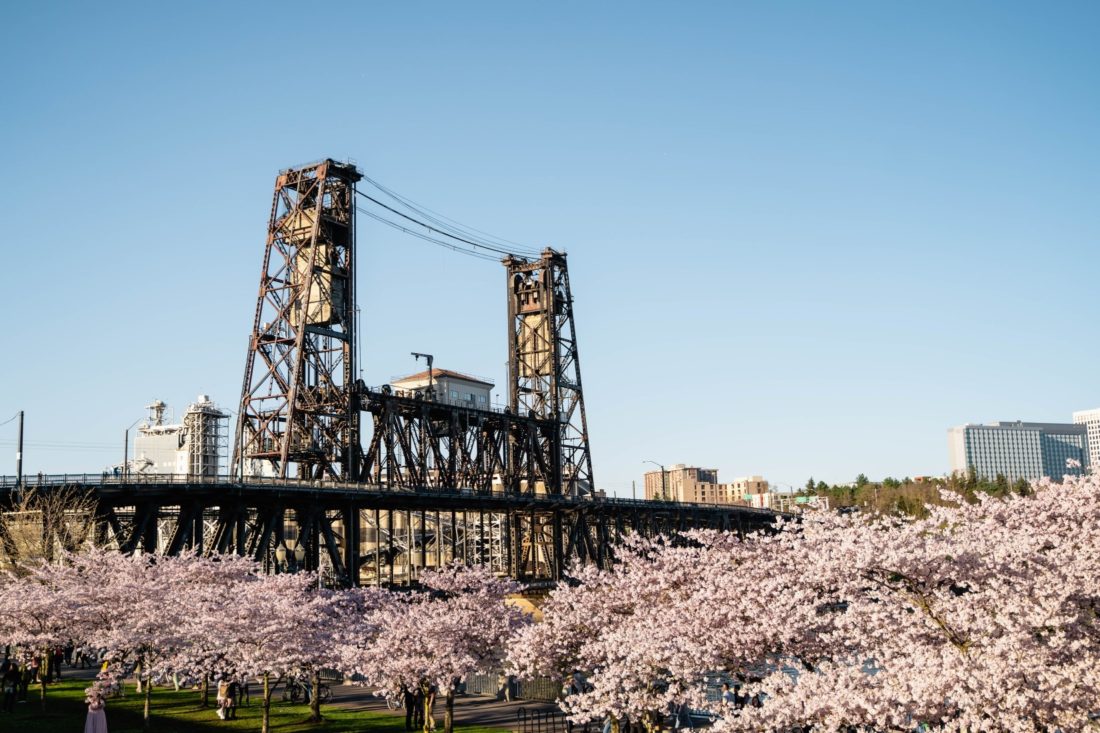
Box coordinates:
[0,474,774,586]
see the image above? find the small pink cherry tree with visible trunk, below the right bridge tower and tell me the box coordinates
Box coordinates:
[342,565,527,733]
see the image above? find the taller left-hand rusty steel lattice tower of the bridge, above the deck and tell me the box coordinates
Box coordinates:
[233,160,362,480]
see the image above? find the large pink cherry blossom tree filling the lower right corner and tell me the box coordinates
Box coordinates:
[724,475,1100,731]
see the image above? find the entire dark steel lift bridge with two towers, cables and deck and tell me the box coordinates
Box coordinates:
[0,160,774,586]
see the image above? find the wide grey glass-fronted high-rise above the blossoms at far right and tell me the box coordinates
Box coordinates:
[947,422,1089,481]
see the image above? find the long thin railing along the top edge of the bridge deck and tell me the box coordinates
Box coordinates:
[0,472,776,517]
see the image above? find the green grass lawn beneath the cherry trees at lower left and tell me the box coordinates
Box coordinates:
[0,679,510,733]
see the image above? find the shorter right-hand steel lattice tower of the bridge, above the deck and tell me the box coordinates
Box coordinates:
[503,248,593,496]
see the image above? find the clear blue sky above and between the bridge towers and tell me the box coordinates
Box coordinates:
[0,2,1100,495]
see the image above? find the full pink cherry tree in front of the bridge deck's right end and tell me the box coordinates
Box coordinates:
[510,533,813,731]
